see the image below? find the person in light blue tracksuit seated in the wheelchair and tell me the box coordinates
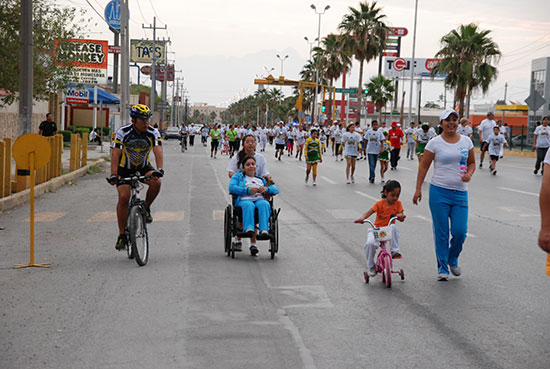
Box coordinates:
[229,156,279,256]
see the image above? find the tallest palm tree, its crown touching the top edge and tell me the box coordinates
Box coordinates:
[338,1,389,119]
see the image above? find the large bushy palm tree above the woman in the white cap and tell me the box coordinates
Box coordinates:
[432,23,502,117]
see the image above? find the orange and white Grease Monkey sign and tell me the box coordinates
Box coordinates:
[54,39,109,85]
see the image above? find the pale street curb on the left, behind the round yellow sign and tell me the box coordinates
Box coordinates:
[0,159,105,214]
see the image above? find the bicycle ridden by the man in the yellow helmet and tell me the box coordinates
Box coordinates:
[106,172,162,266]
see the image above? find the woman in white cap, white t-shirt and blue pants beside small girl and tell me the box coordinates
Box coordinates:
[413,109,475,281]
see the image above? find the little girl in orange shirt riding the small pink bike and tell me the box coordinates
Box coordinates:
[356,180,405,277]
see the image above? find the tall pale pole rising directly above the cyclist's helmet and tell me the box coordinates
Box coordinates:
[120,0,130,126]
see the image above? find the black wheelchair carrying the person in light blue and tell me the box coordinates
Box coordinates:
[223,195,281,259]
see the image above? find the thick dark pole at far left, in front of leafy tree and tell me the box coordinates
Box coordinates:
[18,0,34,136]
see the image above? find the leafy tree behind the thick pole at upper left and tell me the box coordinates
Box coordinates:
[0,0,90,105]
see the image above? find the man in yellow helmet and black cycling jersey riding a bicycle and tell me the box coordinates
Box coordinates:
[109,104,164,251]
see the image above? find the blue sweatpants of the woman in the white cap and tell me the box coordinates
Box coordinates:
[430,185,468,274]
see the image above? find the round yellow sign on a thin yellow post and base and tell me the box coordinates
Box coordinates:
[13,133,51,269]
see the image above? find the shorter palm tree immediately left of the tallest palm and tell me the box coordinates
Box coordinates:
[313,34,351,117]
